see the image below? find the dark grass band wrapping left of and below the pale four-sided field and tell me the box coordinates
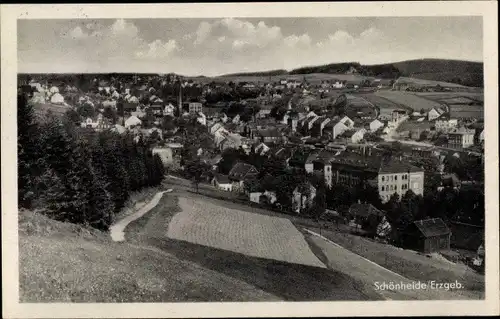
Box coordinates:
[126,191,382,301]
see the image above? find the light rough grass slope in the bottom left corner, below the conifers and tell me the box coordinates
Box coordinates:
[19,211,281,302]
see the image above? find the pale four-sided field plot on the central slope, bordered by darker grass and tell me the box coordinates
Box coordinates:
[167,197,325,268]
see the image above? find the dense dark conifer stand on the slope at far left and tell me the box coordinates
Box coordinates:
[17,95,164,230]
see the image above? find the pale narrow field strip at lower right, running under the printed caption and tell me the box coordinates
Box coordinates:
[306,230,480,300]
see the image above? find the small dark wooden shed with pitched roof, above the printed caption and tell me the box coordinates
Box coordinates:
[402,218,451,253]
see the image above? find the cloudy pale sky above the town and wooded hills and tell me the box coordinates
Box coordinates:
[17,16,483,76]
